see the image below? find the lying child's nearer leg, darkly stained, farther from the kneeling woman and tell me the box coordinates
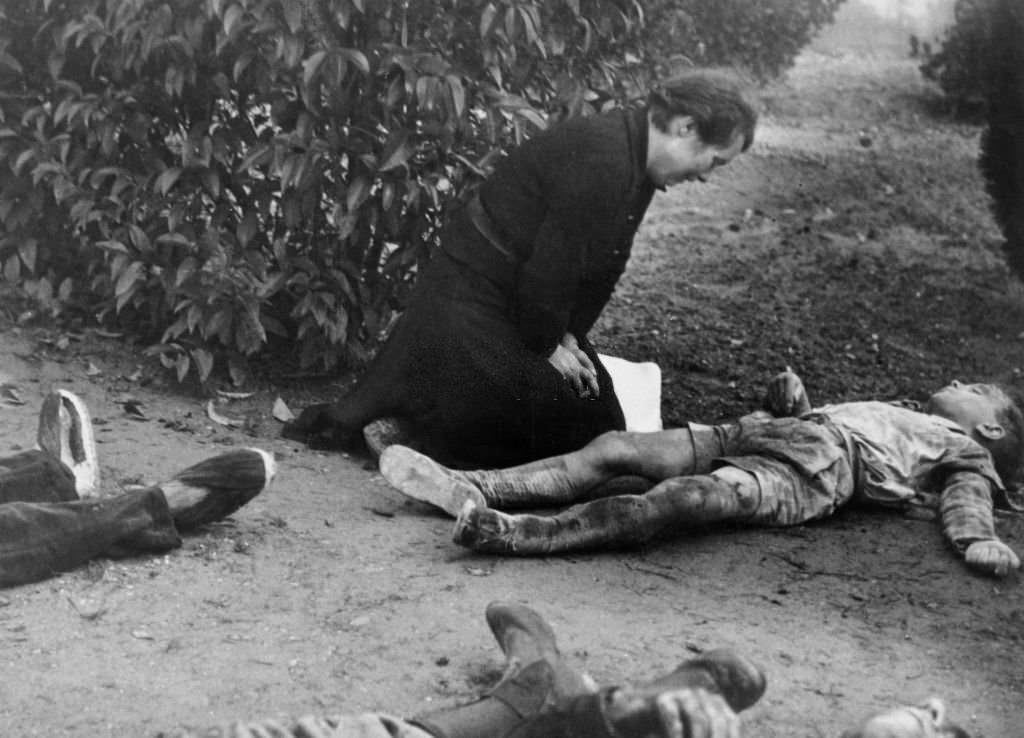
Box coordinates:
[453,467,761,556]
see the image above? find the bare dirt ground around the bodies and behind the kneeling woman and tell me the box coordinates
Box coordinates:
[0,5,1024,738]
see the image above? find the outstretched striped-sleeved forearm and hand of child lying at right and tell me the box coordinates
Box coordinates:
[940,472,1020,576]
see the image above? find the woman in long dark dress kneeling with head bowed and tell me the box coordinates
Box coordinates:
[286,66,757,466]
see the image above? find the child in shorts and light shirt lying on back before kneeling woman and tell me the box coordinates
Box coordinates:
[381,370,1024,576]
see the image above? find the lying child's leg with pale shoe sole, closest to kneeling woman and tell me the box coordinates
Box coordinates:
[380,428,711,517]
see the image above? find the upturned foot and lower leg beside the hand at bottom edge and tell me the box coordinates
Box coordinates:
[414,602,596,738]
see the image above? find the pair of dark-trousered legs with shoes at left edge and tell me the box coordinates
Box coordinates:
[0,390,274,587]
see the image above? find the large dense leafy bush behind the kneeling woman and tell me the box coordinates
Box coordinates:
[0,0,840,381]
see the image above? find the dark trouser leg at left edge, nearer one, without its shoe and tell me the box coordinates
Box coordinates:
[0,487,181,587]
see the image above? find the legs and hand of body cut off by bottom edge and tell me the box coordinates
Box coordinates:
[161,602,765,738]
